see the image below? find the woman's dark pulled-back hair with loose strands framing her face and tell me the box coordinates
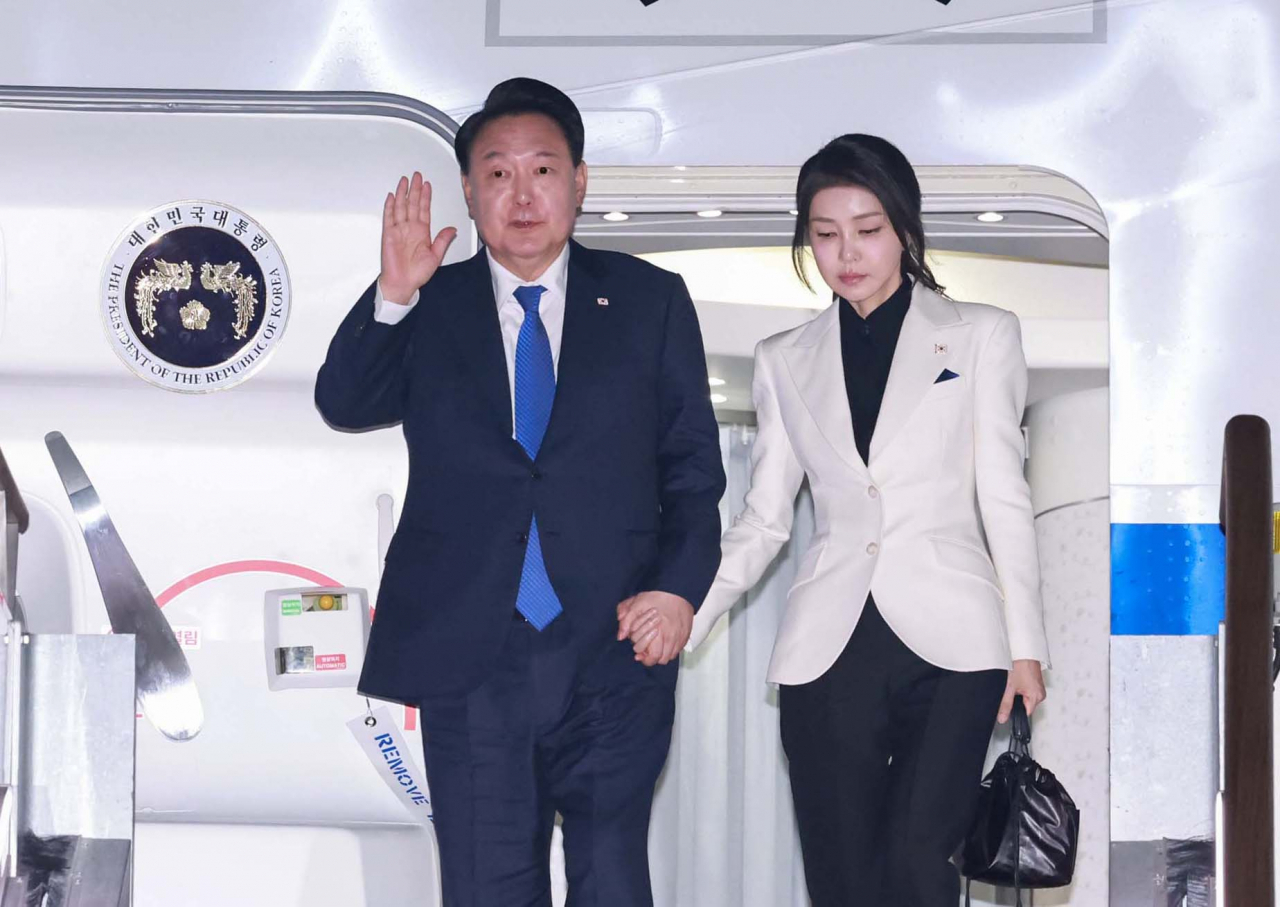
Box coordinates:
[791,133,943,293]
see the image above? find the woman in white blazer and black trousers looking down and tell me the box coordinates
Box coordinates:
[632,136,1048,907]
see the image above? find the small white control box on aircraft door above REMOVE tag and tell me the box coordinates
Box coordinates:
[264,586,369,690]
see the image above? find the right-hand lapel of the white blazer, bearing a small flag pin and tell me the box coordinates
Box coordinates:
[870,284,965,463]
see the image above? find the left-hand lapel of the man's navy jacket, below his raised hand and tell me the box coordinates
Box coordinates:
[440,248,512,438]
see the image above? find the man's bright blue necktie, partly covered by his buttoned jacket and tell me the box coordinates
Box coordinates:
[516,287,563,629]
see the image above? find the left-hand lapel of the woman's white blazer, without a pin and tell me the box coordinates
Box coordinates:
[782,301,867,475]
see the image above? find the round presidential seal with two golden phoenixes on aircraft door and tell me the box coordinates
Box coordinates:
[102,201,289,393]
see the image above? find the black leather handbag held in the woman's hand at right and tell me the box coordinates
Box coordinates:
[955,696,1080,907]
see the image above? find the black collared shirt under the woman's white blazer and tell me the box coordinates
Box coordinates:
[840,278,911,463]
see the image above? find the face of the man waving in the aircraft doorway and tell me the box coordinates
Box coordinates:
[462,114,586,280]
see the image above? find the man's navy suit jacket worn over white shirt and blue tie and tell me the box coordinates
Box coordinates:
[315,243,724,702]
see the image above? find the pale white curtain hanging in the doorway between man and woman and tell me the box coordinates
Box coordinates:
[649,426,813,907]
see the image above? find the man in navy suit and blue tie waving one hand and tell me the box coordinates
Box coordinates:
[316,79,724,907]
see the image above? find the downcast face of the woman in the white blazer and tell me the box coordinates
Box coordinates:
[809,185,902,310]
